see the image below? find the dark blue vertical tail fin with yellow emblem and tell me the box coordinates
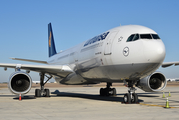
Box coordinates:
[48,23,57,57]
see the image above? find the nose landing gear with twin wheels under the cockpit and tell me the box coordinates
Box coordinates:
[124,81,138,104]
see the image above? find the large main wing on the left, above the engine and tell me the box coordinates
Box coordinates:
[0,63,73,77]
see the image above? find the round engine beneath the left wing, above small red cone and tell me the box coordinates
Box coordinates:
[8,71,32,94]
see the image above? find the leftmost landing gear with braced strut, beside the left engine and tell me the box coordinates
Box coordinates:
[35,73,52,97]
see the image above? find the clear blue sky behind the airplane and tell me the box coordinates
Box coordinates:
[0,0,179,82]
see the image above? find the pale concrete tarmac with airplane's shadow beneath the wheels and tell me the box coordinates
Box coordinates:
[0,82,179,120]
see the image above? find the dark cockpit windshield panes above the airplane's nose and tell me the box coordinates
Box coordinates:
[127,34,160,42]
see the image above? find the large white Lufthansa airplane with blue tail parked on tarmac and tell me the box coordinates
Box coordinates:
[0,23,174,104]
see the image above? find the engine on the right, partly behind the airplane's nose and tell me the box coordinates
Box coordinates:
[136,72,167,92]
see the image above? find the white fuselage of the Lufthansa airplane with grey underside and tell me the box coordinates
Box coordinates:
[48,25,165,84]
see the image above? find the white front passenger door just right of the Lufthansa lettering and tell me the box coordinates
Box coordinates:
[104,31,117,55]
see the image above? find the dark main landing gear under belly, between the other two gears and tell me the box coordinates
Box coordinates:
[100,82,116,96]
